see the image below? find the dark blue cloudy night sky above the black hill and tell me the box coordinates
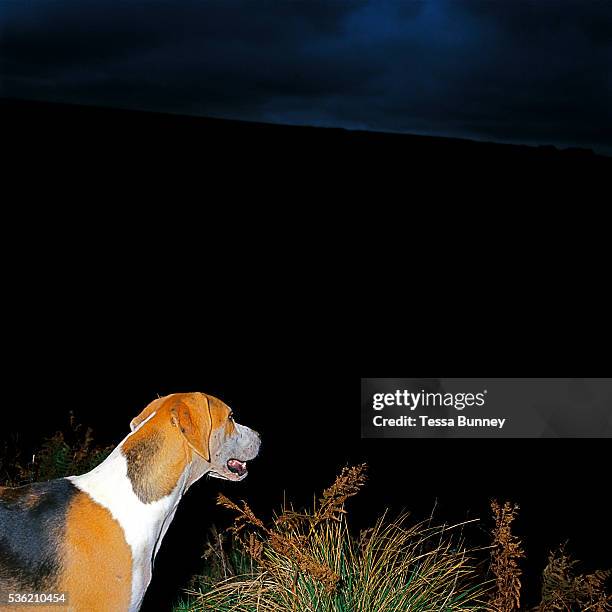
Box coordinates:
[0,0,612,153]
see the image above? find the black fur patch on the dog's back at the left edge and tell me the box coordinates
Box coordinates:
[0,478,79,593]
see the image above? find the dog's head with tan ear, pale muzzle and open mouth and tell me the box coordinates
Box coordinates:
[130,393,260,484]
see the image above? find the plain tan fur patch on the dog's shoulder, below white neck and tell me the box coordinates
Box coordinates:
[56,493,132,612]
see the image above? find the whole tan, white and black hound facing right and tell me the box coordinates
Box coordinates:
[0,393,260,612]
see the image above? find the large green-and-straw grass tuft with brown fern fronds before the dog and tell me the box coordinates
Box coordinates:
[175,465,489,612]
